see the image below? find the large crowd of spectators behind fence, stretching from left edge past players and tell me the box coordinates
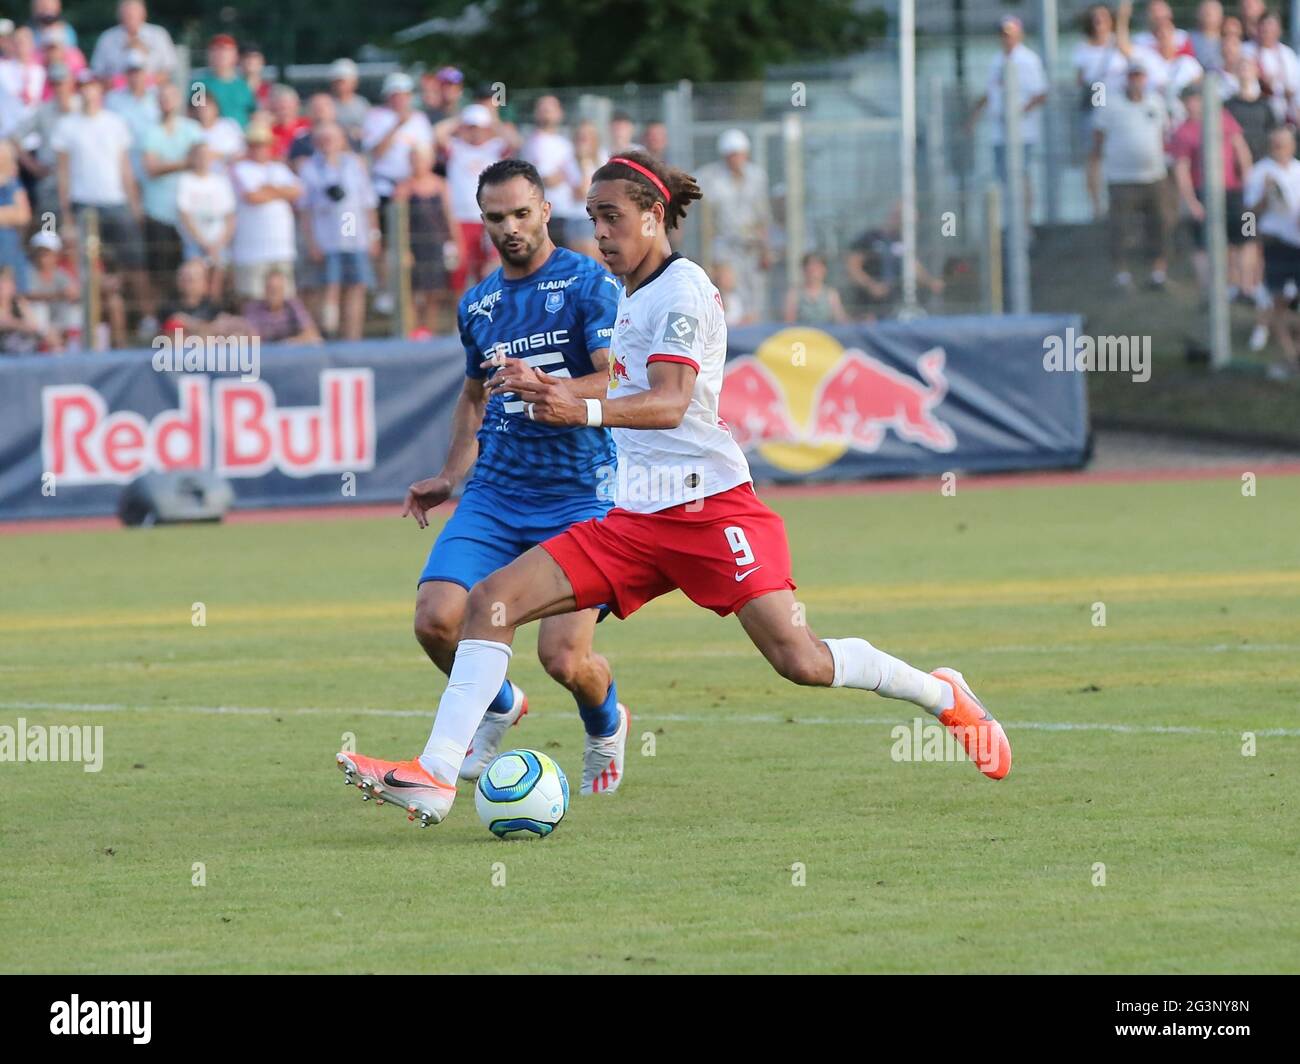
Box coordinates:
[0,0,943,352]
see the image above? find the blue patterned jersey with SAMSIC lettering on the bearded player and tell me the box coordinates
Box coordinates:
[456,247,623,498]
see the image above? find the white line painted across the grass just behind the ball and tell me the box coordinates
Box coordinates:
[0,702,1300,739]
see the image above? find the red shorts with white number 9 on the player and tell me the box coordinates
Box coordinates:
[542,484,794,617]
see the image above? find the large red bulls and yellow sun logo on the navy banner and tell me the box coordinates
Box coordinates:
[719,329,957,472]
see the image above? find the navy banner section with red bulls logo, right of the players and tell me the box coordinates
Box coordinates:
[719,315,1088,481]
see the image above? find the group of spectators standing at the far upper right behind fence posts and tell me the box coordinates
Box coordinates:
[1066,0,1300,377]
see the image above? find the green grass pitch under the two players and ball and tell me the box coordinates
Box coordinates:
[0,473,1300,973]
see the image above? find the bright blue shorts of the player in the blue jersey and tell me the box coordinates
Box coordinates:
[419,480,612,591]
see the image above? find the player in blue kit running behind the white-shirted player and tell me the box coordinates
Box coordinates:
[390,159,629,795]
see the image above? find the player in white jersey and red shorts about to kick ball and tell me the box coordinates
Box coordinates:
[337,152,1011,826]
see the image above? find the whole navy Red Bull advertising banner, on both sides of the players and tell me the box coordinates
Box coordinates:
[0,316,1088,518]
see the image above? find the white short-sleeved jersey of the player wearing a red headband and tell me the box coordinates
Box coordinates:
[608,255,751,514]
